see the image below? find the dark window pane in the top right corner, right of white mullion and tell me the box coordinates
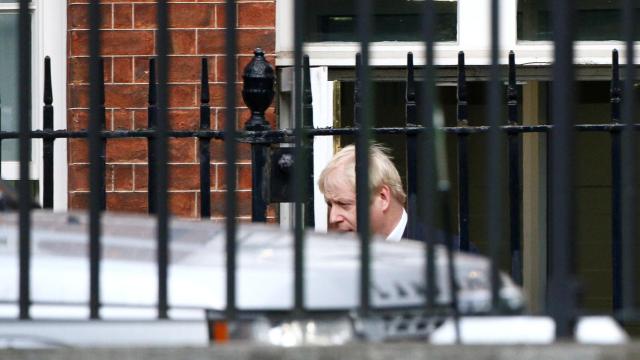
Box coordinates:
[518,0,640,41]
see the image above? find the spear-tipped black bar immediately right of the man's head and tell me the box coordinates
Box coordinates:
[405,52,418,239]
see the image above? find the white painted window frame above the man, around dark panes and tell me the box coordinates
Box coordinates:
[276,0,640,67]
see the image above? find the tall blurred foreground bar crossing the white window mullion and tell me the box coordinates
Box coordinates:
[487,0,502,312]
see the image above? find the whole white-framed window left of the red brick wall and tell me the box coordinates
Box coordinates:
[0,0,67,209]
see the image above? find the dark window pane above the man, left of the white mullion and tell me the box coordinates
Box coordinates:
[304,0,458,41]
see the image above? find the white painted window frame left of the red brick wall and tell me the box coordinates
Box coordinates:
[0,0,67,210]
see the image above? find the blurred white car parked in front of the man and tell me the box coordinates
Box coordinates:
[0,210,524,343]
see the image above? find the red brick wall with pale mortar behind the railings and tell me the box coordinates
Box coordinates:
[67,0,275,218]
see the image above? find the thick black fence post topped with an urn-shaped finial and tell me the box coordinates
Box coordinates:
[242,48,275,222]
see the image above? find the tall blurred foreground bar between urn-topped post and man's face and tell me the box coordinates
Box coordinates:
[293,0,307,315]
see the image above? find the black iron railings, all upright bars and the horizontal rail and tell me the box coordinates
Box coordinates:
[0,0,640,336]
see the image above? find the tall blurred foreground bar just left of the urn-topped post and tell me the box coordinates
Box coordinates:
[224,0,236,319]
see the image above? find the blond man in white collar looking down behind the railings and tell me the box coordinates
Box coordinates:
[318,144,407,241]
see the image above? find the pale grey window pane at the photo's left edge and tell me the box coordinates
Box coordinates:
[0,11,19,161]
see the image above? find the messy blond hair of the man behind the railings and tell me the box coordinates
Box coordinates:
[318,144,407,204]
